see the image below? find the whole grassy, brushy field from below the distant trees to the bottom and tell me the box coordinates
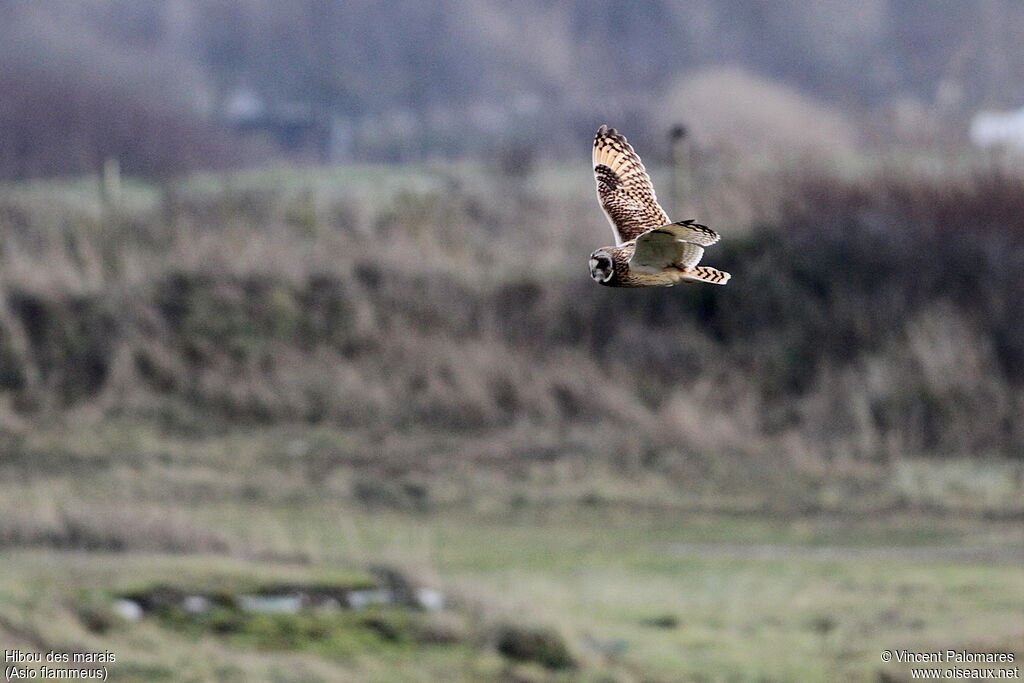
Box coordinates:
[0,162,1024,683]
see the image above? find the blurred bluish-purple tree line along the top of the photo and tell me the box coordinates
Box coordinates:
[0,0,1024,178]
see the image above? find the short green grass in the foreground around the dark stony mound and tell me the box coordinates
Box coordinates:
[0,508,1024,681]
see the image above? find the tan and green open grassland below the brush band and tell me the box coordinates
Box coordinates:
[0,424,1024,681]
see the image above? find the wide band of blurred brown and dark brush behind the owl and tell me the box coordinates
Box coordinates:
[0,162,1024,466]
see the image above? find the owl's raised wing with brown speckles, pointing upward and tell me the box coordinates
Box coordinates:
[594,126,669,244]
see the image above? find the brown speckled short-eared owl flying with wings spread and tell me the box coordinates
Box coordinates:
[590,126,731,287]
